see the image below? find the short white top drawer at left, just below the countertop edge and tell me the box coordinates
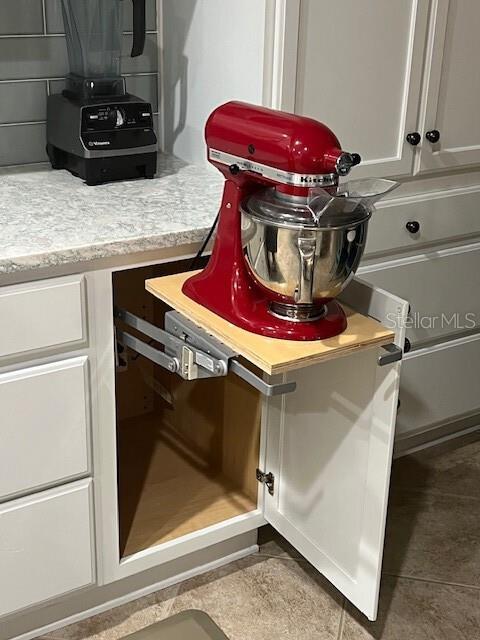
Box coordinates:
[0,276,86,358]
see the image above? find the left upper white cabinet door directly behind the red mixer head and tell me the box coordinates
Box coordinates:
[290,0,430,177]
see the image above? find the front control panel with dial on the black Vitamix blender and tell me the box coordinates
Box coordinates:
[81,102,157,151]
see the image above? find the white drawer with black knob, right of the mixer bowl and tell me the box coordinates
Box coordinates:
[365,190,480,255]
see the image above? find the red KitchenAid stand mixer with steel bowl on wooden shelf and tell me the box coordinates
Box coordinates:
[183,102,396,340]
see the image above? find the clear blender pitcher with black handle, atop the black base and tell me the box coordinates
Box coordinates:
[62,0,146,97]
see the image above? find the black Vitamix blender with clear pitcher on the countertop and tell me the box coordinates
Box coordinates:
[47,0,157,185]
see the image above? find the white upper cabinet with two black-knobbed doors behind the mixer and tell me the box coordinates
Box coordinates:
[163,0,480,178]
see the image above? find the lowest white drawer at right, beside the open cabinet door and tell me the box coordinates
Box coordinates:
[397,335,480,435]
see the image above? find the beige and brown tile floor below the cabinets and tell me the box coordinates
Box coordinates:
[42,434,480,640]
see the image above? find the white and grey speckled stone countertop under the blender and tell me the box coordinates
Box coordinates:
[0,155,223,275]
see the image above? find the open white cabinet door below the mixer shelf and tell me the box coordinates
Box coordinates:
[264,283,408,620]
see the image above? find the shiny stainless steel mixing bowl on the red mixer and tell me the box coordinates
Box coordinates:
[242,190,371,321]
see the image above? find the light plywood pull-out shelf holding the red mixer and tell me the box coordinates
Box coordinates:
[145,272,394,375]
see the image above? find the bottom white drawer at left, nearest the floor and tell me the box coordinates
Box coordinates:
[0,480,95,616]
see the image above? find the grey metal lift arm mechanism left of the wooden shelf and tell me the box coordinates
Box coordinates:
[114,307,296,396]
